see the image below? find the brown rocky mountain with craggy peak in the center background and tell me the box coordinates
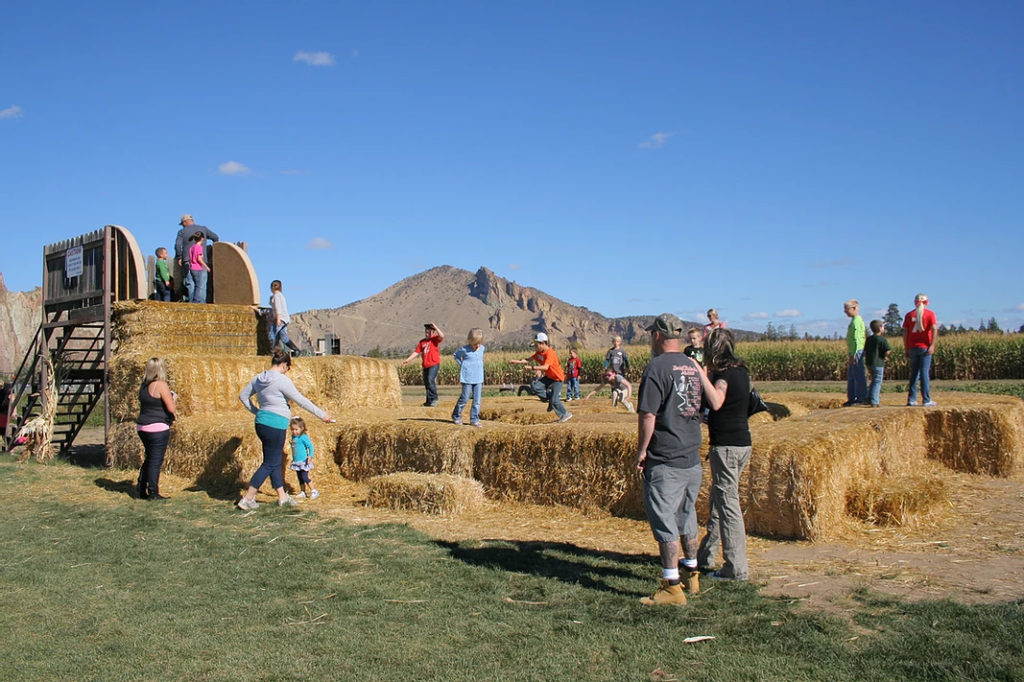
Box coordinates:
[289,265,720,354]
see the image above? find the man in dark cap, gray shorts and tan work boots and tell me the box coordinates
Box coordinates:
[637,312,722,605]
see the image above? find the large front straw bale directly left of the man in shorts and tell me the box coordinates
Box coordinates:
[473,423,636,510]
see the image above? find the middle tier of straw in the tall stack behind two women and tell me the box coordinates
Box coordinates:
[109,352,401,420]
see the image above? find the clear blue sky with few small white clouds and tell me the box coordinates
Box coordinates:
[0,0,1024,334]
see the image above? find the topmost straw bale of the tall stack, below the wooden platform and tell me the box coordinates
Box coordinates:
[112,301,259,356]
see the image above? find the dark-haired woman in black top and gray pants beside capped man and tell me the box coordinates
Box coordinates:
[697,327,751,581]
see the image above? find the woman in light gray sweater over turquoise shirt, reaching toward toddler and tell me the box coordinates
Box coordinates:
[239,348,333,503]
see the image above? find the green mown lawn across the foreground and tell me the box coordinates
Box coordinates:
[0,456,1024,681]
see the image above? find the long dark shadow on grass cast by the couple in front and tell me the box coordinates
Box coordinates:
[436,540,657,597]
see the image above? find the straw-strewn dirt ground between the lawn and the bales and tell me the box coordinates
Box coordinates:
[66,428,1024,610]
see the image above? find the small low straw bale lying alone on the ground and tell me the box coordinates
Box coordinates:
[367,472,484,516]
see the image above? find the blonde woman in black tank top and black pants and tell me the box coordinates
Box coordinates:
[135,357,177,500]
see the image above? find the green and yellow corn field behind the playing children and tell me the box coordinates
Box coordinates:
[395,334,1024,385]
